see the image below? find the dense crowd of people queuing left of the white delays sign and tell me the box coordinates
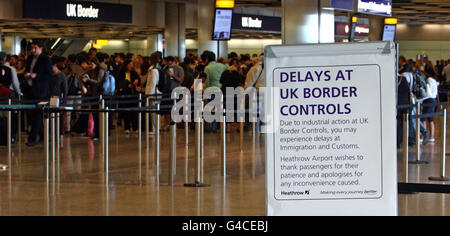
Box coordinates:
[0,42,264,147]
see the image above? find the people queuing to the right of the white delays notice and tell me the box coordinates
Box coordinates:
[397,56,450,147]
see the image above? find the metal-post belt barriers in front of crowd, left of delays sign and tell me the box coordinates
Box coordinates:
[0,94,290,187]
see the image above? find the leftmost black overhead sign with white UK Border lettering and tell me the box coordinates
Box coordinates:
[22,0,133,24]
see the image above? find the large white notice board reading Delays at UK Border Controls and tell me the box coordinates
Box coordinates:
[264,42,397,216]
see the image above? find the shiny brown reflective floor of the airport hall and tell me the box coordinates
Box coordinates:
[0,114,450,216]
